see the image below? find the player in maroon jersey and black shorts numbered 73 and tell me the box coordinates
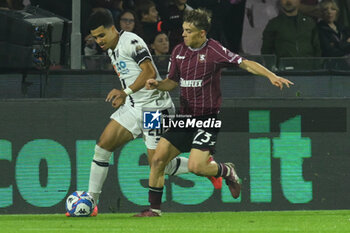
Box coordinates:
[135,9,293,217]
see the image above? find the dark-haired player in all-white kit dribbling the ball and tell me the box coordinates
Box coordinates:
[65,8,221,216]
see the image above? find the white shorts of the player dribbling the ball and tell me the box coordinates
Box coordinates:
[111,104,175,150]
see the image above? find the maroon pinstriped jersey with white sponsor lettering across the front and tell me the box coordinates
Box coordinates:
[168,39,243,116]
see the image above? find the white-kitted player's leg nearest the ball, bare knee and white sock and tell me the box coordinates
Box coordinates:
[89,120,134,206]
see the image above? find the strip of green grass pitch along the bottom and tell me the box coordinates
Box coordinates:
[0,210,350,233]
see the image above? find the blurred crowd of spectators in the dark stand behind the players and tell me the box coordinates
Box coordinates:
[0,0,350,68]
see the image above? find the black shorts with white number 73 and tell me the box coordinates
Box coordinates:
[162,115,219,155]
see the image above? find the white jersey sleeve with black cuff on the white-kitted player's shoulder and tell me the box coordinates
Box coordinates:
[127,38,151,65]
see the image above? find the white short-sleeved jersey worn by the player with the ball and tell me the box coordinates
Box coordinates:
[108,31,172,109]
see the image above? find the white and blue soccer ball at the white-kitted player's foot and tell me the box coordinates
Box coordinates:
[66,191,94,217]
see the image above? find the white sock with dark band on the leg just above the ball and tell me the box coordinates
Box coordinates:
[88,145,112,204]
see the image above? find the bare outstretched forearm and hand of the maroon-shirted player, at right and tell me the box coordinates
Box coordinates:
[239,60,294,90]
